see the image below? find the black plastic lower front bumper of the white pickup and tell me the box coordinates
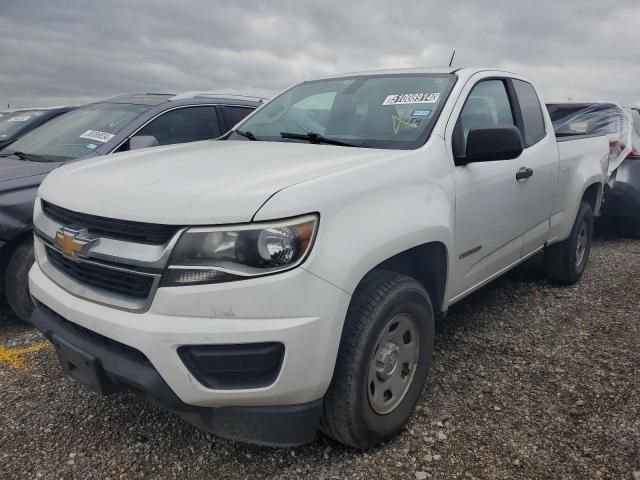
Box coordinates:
[31,305,322,446]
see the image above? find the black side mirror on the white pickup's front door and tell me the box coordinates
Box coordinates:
[465,125,524,163]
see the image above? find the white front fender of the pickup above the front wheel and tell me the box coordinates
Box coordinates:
[254,137,455,295]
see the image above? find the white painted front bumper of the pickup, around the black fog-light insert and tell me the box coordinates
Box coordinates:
[29,264,350,407]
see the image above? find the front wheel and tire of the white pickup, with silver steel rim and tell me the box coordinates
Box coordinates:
[321,270,434,449]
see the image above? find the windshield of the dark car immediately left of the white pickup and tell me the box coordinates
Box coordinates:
[2,103,151,160]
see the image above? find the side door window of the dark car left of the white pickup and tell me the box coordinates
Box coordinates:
[136,106,220,145]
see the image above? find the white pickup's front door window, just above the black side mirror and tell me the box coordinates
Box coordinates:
[453,80,515,158]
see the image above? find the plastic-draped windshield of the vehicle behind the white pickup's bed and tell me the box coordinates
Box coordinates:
[547,103,624,135]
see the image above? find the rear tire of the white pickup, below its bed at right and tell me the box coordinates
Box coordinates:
[544,202,593,284]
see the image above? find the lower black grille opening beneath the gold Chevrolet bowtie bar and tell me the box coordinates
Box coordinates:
[47,248,153,299]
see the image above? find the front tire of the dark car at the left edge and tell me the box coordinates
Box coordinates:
[4,239,34,322]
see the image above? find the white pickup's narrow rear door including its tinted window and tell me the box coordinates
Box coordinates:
[510,78,559,256]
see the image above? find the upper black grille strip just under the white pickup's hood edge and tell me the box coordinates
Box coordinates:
[42,200,184,245]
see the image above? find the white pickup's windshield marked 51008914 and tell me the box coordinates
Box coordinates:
[228,74,455,149]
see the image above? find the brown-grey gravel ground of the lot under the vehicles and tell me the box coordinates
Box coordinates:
[0,231,640,480]
